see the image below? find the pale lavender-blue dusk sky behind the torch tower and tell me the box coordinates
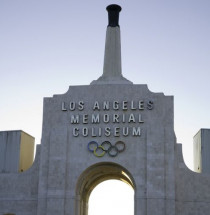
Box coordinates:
[0,0,210,213]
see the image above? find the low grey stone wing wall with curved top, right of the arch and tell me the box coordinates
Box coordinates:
[176,145,210,215]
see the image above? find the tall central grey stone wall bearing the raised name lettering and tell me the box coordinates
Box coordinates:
[35,84,175,214]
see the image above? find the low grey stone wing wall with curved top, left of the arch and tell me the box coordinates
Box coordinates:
[0,146,40,215]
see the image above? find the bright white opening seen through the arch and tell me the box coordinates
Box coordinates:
[88,180,134,215]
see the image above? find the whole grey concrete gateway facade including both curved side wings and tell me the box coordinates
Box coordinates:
[0,6,210,215]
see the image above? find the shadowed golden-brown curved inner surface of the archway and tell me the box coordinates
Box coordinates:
[76,162,135,215]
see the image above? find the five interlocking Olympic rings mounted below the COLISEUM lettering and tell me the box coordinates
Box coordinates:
[87,141,126,157]
